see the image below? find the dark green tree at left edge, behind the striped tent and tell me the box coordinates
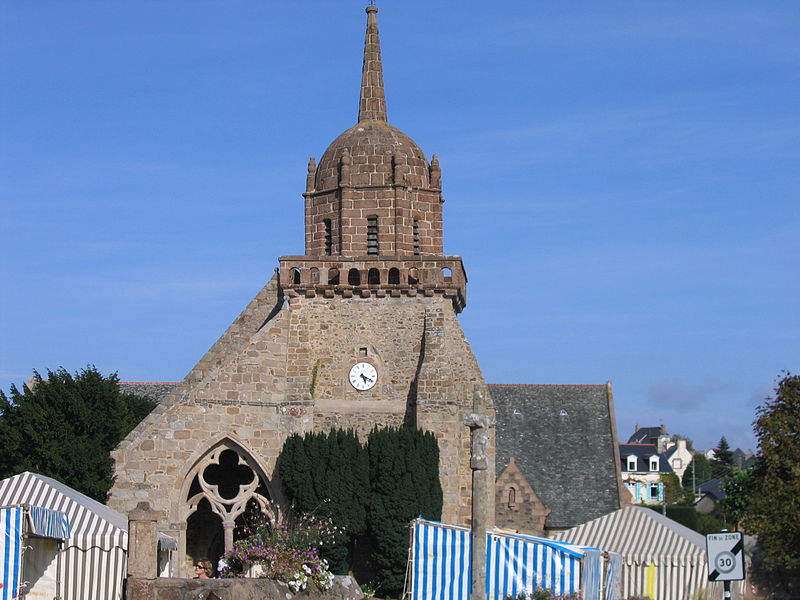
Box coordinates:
[0,366,156,502]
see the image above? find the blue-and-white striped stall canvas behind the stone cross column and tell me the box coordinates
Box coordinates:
[409,519,600,600]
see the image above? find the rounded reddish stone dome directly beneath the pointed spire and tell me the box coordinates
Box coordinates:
[315,121,430,190]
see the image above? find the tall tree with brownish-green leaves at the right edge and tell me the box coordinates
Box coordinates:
[745,373,800,569]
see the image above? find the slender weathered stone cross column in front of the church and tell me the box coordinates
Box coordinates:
[464,385,495,600]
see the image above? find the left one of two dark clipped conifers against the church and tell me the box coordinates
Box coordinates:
[278,430,369,573]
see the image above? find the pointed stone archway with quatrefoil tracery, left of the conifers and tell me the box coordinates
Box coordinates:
[184,439,278,564]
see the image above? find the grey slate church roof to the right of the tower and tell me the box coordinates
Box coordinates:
[489,384,621,529]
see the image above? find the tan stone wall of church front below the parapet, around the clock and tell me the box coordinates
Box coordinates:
[109,285,494,574]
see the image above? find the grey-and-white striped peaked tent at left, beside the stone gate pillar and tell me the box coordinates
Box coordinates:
[0,472,177,600]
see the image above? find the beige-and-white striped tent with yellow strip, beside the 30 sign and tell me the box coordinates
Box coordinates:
[553,506,741,600]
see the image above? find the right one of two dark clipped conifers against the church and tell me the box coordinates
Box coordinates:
[367,428,443,596]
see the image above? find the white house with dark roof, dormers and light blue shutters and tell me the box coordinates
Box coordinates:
[619,444,675,504]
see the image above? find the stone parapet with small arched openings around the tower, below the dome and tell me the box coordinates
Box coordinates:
[278,255,467,312]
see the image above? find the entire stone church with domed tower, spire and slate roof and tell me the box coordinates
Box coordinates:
[109,6,624,575]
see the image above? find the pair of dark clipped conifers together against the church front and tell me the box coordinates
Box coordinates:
[278,428,442,596]
